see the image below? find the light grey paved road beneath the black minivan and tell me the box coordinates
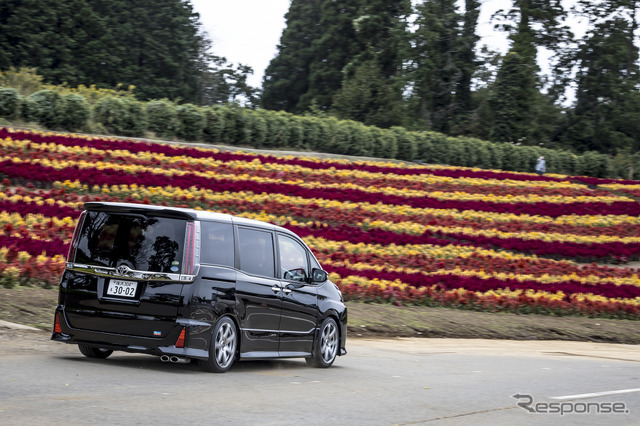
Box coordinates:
[0,330,640,425]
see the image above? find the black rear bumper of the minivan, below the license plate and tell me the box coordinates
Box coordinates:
[51,307,211,360]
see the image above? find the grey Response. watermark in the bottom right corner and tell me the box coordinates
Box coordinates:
[511,393,629,416]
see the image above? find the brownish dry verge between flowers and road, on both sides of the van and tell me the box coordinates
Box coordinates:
[0,287,640,344]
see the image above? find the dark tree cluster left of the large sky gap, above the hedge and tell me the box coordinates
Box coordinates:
[0,0,255,104]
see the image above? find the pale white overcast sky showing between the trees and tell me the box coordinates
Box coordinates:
[191,0,575,87]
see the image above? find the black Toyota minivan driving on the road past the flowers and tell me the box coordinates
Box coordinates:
[51,202,347,372]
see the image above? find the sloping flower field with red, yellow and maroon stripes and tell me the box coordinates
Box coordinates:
[0,128,640,319]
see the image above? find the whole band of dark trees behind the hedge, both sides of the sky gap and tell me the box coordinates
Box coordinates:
[0,0,640,166]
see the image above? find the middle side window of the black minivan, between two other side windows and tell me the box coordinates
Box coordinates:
[238,228,275,277]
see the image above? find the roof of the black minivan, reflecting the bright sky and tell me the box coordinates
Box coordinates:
[84,201,295,236]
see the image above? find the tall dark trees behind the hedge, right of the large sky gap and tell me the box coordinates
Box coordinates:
[261,0,640,159]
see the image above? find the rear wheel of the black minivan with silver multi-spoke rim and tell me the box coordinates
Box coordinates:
[199,317,238,373]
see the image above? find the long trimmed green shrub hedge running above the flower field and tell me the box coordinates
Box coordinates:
[0,88,613,177]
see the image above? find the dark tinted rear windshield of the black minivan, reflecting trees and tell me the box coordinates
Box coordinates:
[74,211,186,273]
